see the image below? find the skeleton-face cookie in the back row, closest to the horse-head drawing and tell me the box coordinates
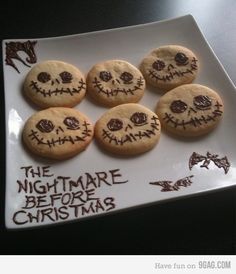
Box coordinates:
[24,61,86,108]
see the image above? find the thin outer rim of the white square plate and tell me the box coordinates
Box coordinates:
[2,14,236,230]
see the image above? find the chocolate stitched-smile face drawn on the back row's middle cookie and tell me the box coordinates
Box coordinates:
[93,71,144,97]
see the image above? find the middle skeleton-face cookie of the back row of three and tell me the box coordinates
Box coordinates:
[87,60,145,107]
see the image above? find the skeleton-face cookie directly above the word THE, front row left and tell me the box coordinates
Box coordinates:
[23,107,93,160]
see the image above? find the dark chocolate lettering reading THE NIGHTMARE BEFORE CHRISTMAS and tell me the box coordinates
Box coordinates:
[12,166,128,225]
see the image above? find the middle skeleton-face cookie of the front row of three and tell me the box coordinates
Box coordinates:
[95,103,161,155]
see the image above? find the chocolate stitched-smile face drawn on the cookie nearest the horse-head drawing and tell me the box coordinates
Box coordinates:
[30,71,86,97]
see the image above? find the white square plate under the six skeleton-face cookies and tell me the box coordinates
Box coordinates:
[3,15,236,228]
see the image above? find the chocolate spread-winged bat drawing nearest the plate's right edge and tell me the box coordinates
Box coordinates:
[189,152,230,174]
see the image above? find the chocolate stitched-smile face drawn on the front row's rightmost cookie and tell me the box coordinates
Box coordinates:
[163,95,223,130]
